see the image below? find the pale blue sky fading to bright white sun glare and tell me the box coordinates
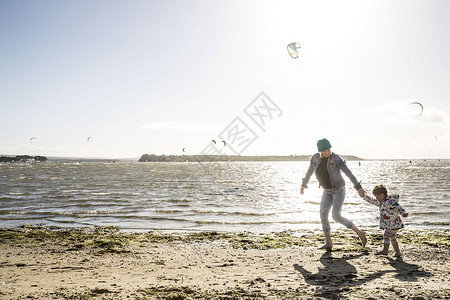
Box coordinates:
[0,0,450,159]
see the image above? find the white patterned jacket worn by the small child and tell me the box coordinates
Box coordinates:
[363,195,406,230]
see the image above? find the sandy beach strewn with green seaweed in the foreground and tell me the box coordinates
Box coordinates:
[0,227,450,299]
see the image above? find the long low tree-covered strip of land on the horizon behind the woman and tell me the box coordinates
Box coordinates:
[139,154,363,162]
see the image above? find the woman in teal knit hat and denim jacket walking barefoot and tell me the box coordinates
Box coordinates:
[300,139,367,250]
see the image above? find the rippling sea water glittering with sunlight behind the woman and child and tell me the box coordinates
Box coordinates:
[0,160,450,233]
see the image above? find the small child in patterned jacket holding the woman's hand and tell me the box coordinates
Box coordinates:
[363,184,408,257]
